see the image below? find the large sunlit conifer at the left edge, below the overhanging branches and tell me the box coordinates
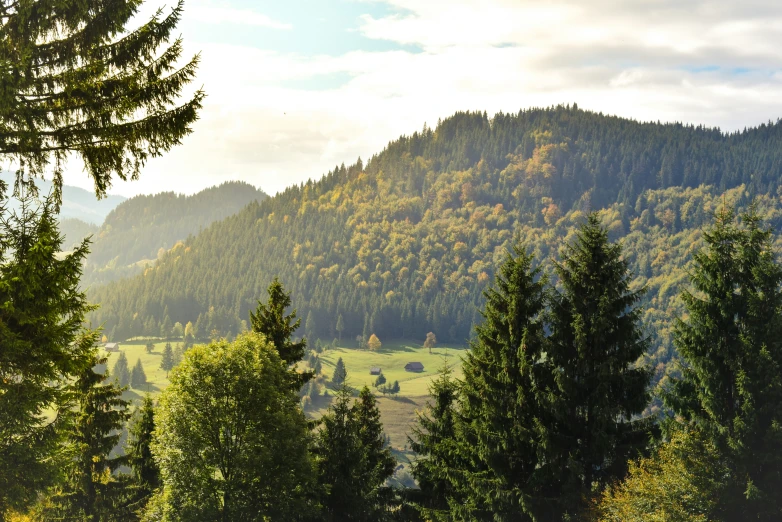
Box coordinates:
[0,196,99,519]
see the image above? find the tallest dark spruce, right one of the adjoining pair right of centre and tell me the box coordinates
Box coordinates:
[543,212,651,516]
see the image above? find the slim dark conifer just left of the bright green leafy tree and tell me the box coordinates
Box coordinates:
[125,395,160,498]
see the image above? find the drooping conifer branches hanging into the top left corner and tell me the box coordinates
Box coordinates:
[0,0,204,199]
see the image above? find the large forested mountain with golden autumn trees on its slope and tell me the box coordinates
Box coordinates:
[90,106,782,378]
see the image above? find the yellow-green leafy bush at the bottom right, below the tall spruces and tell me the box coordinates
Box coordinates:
[593,431,730,522]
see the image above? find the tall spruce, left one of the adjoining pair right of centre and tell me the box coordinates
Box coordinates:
[456,245,545,521]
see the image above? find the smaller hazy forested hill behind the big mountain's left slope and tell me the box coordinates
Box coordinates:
[79,181,267,285]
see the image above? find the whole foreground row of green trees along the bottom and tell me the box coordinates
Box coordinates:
[6,191,782,522]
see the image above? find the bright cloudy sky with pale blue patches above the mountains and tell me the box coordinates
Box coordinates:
[59,0,782,196]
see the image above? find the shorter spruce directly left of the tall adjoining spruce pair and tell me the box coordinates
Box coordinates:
[408,359,463,520]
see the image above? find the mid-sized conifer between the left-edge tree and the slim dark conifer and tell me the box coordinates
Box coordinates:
[44,358,129,521]
